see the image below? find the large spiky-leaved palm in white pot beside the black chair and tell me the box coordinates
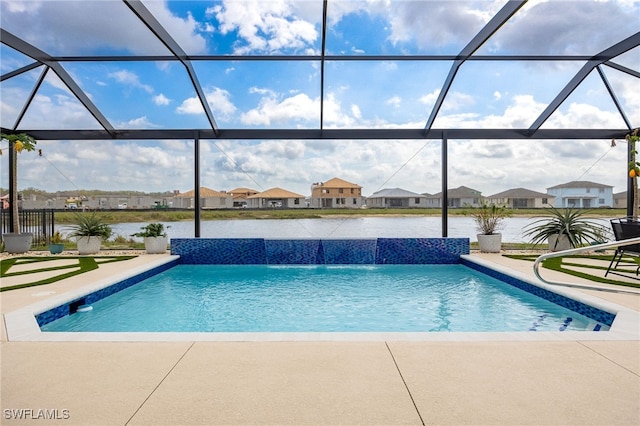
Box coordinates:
[524,207,607,251]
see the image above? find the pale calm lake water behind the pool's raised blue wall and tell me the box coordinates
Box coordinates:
[97,216,609,243]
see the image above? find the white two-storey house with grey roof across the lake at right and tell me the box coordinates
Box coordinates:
[547,181,613,209]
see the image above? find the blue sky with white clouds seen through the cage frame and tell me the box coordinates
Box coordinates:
[0,0,640,195]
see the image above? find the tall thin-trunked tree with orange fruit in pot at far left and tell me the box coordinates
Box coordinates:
[0,133,38,253]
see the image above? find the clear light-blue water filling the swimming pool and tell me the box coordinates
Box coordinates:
[41,264,608,332]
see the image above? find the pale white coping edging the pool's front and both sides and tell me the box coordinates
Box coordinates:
[4,255,640,342]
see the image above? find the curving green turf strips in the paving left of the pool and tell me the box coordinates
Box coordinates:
[0,256,136,292]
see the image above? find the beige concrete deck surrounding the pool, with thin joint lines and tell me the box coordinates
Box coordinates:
[0,254,640,425]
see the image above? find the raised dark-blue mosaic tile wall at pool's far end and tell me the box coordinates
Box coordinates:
[171,238,469,265]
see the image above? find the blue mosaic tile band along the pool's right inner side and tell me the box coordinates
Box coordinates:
[460,258,616,326]
